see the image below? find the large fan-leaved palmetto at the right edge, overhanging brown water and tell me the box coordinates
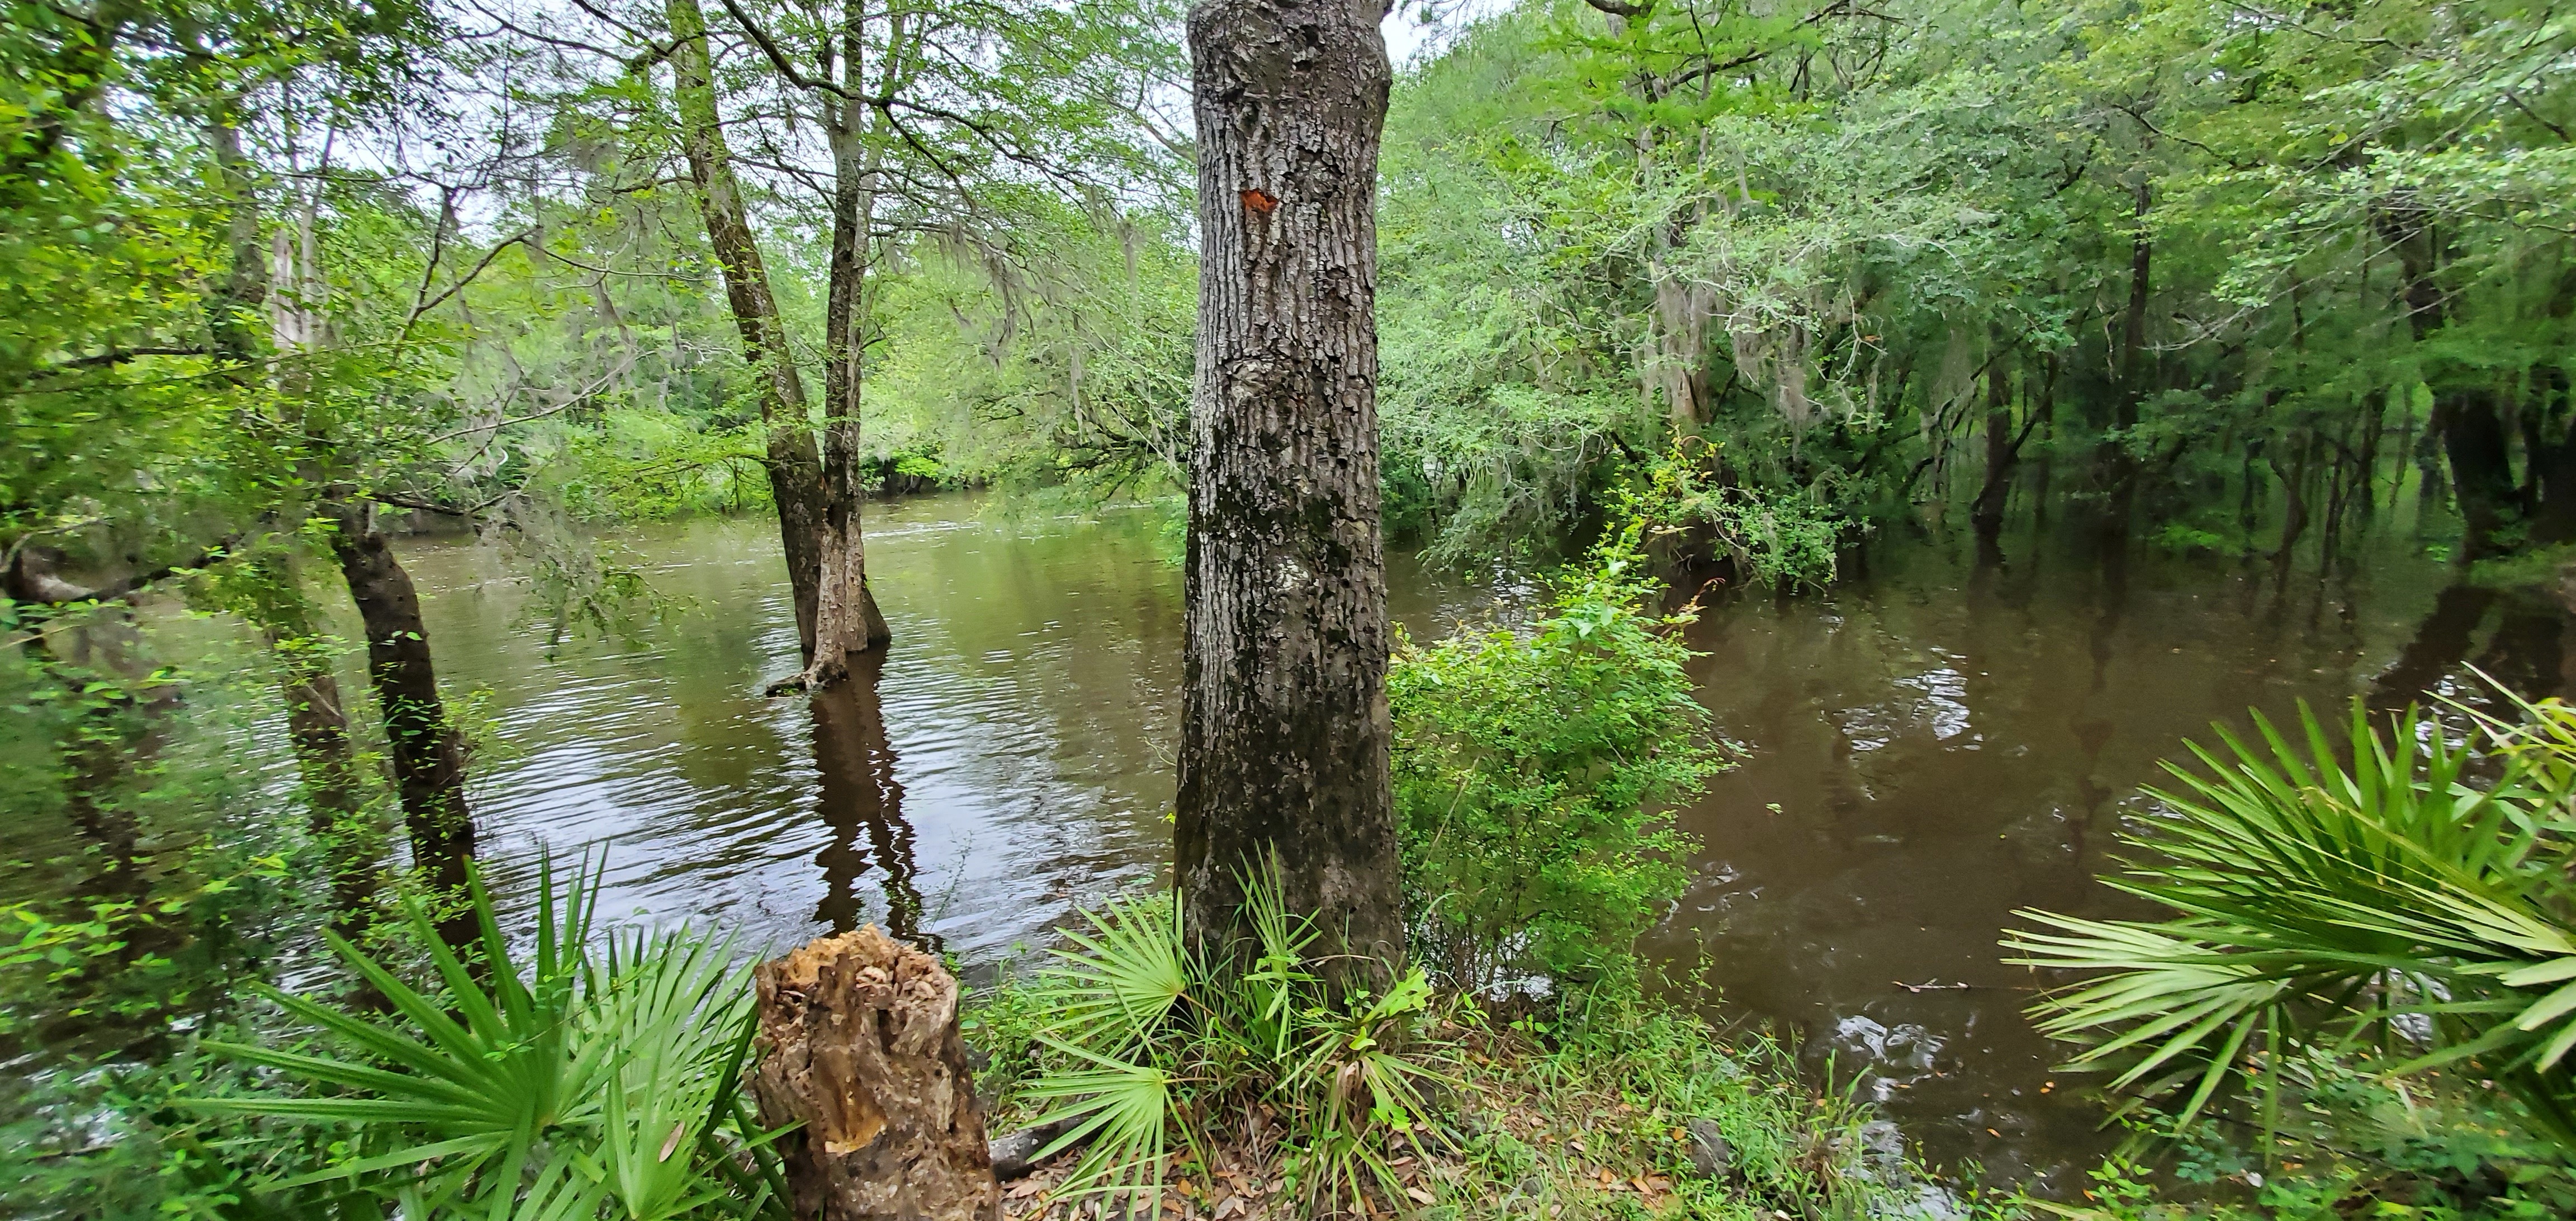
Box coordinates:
[2004,701,2576,1144]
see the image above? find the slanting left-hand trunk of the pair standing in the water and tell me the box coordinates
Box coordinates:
[667,0,825,665]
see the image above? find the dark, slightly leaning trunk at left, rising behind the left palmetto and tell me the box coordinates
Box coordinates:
[332,502,476,945]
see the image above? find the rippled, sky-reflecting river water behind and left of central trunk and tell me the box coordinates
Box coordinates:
[404,497,1486,966]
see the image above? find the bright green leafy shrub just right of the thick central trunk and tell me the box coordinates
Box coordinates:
[1386,526,1723,992]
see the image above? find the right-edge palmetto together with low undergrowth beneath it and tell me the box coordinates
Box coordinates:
[2004,698,2576,1218]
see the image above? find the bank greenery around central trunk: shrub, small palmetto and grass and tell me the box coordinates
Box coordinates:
[971,533,1919,1221]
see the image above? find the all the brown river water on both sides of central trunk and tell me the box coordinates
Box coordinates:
[391,497,2563,1185]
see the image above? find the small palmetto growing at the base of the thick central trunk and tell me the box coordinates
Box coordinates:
[1028,863,1440,1213]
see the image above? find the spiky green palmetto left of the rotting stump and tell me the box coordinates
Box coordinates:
[203,870,785,1221]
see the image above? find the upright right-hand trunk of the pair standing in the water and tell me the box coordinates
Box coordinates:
[796,0,902,688]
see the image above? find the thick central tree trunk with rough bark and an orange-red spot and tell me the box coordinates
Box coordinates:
[1177,0,1404,979]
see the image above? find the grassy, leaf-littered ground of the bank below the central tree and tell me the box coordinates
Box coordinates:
[976,963,1922,1221]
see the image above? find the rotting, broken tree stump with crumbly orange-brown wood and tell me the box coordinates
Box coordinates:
[752,925,1002,1221]
